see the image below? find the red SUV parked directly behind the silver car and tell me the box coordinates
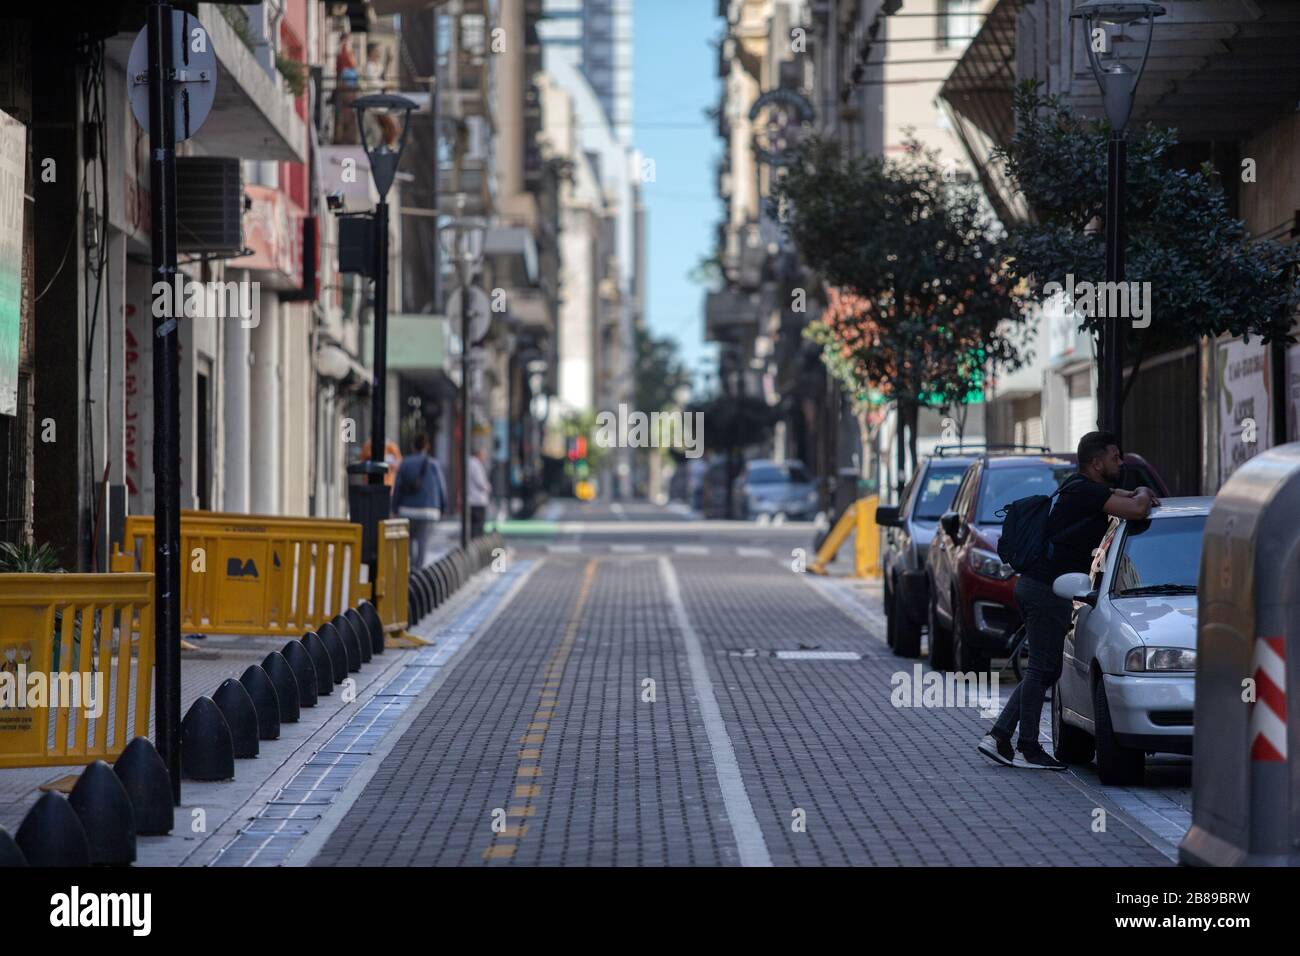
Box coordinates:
[926,454,1169,672]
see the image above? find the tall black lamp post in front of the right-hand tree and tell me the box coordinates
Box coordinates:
[1071,0,1165,438]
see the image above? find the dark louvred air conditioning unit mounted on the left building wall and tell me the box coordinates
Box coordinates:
[176,156,244,258]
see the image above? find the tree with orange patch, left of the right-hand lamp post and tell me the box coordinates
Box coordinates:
[774,138,1024,470]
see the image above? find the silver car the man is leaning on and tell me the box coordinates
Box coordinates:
[1052,498,1214,784]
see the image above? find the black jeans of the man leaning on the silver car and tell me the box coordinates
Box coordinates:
[993,575,1073,750]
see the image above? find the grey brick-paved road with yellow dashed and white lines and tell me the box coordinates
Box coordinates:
[313,509,1169,865]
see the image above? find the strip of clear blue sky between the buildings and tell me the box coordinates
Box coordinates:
[633,0,723,392]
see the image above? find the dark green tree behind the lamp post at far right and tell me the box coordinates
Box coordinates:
[995,81,1300,403]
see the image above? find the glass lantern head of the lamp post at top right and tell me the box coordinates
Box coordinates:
[1070,0,1165,131]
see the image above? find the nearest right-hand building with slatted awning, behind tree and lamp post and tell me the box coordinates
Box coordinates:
[941,0,1300,494]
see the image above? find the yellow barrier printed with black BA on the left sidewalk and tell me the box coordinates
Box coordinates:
[112,511,367,637]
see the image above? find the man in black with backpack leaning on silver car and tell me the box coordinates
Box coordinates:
[979,432,1160,770]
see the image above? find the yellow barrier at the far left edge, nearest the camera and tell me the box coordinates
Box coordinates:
[0,574,153,769]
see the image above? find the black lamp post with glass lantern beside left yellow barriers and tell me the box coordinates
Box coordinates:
[348,94,416,574]
